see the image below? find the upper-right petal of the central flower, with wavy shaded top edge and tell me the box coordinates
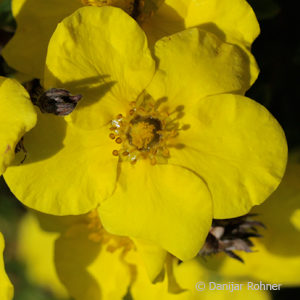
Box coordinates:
[147,28,250,106]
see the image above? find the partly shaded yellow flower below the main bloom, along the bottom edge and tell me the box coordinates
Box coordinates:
[19,212,269,300]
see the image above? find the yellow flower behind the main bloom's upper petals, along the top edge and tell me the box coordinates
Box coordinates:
[3,0,259,81]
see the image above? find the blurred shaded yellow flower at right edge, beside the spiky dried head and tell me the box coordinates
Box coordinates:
[203,163,300,287]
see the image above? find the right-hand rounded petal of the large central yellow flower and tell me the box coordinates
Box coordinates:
[169,94,287,219]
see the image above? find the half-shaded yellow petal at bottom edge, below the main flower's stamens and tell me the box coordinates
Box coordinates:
[55,225,130,300]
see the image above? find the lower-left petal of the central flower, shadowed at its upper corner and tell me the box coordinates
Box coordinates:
[5,114,118,215]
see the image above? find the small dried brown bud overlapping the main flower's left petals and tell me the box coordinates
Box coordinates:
[35,88,82,116]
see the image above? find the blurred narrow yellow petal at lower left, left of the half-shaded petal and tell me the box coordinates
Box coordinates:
[16,213,67,299]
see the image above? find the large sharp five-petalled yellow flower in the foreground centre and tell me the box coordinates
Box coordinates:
[5,7,287,260]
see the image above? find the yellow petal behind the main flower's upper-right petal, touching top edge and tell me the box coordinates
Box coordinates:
[141,0,260,84]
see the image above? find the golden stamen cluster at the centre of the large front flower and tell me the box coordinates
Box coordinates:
[109,95,183,165]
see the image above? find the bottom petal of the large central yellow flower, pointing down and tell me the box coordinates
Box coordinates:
[99,161,212,260]
